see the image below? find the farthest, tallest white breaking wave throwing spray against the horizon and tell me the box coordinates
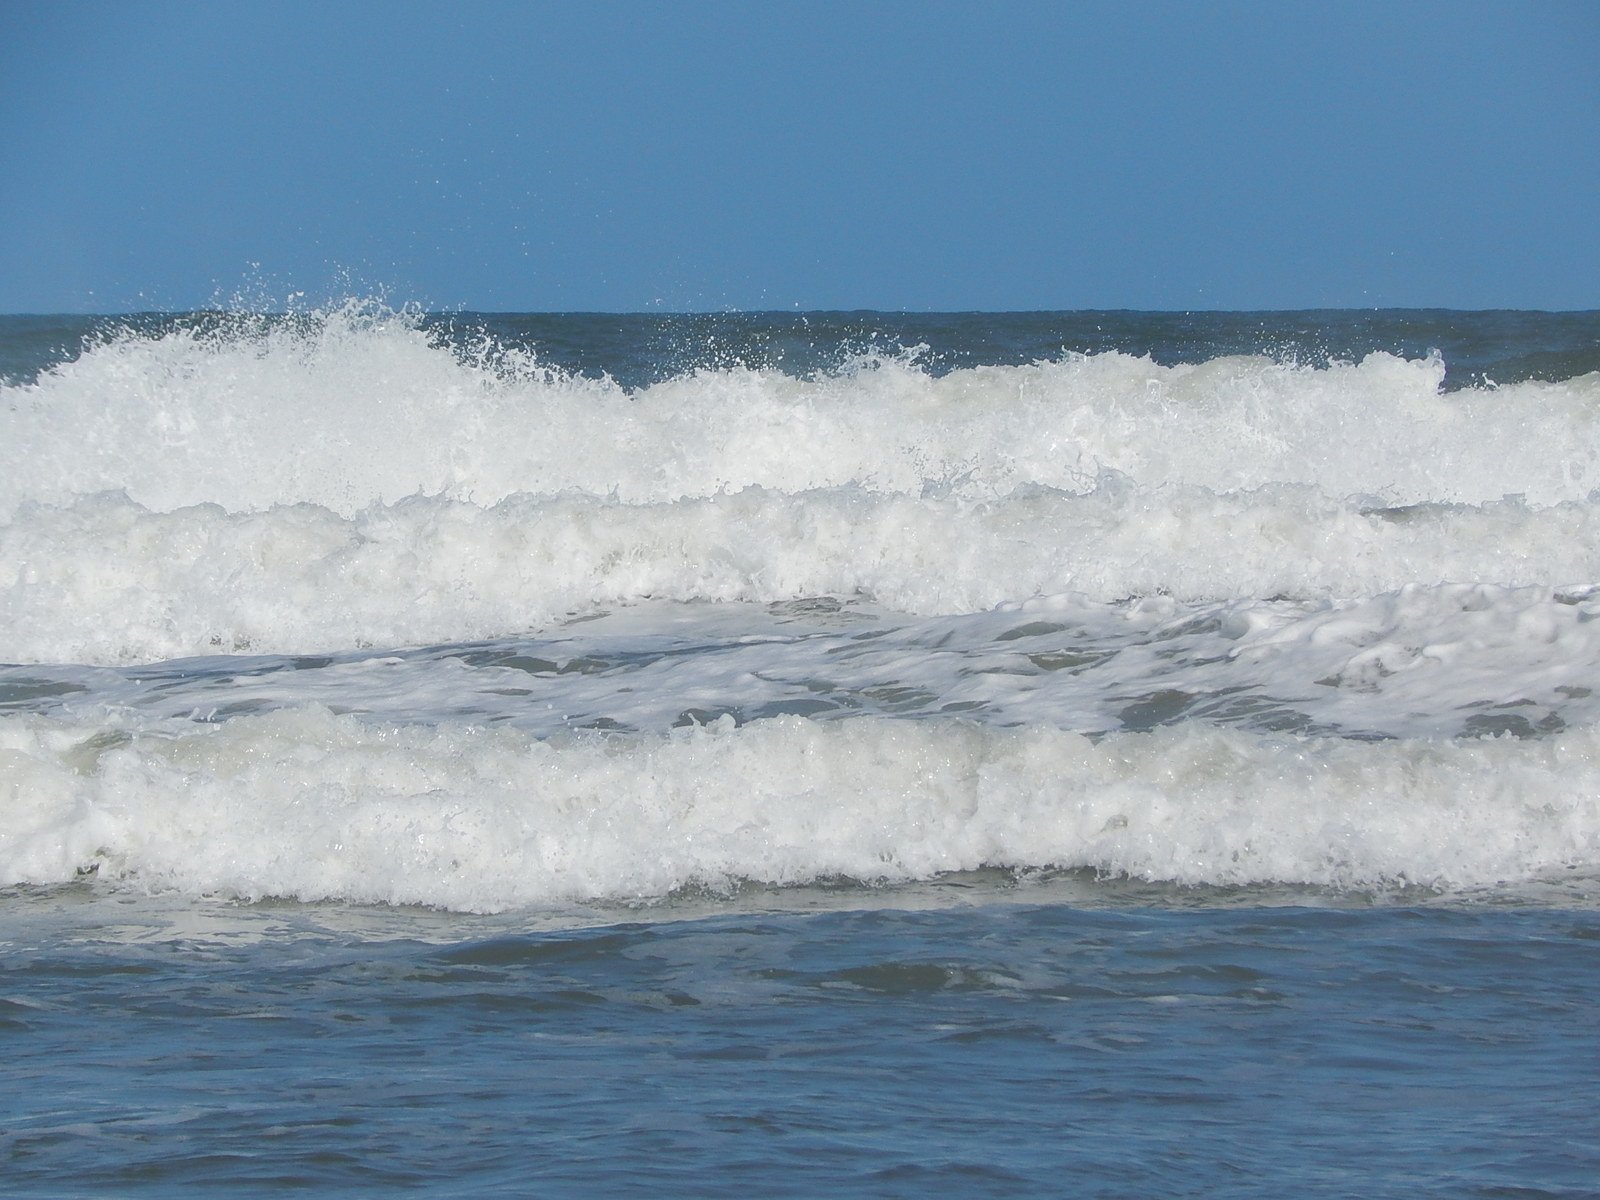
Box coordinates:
[0,306,1600,517]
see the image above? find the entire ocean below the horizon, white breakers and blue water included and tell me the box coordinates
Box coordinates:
[0,299,1600,1198]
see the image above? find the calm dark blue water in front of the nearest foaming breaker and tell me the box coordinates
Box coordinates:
[0,898,1600,1197]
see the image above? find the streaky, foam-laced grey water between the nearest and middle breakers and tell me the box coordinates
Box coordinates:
[12,584,1600,738]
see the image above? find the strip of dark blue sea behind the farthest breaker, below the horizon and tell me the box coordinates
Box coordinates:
[9,309,1600,389]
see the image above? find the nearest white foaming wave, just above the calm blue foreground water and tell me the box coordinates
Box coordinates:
[0,707,1600,910]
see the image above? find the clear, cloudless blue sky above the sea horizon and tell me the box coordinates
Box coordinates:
[0,0,1600,312]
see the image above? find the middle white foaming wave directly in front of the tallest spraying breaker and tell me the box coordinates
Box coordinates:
[0,482,1600,662]
